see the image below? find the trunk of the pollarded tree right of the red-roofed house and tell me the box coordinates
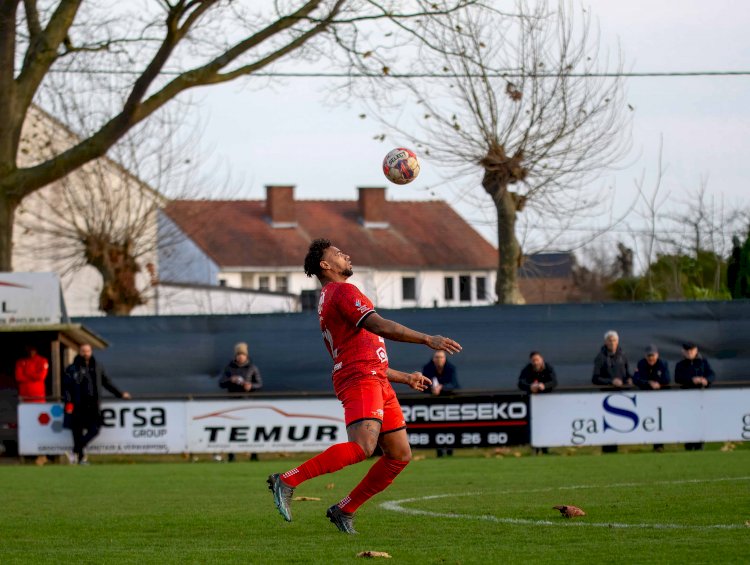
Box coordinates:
[482,171,526,304]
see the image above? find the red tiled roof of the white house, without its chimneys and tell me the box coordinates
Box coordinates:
[166,200,498,270]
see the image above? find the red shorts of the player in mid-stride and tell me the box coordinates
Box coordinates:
[336,379,406,434]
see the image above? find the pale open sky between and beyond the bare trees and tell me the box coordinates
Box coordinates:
[185,0,750,250]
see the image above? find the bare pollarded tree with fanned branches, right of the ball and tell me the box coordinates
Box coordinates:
[356,1,629,303]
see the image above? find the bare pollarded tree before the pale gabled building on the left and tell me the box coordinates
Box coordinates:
[14,103,203,315]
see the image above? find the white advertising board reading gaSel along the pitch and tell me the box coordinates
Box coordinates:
[531,388,750,447]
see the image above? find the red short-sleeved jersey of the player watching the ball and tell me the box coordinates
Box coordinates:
[318,283,388,391]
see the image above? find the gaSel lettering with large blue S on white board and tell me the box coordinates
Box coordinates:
[570,394,664,445]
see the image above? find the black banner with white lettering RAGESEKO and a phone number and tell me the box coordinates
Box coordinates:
[399,394,529,448]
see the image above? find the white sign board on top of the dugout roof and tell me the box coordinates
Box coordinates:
[0,273,62,326]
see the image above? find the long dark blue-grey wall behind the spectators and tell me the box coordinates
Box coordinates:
[76,301,750,394]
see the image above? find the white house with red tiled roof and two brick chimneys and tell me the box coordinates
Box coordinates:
[159,186,497,309]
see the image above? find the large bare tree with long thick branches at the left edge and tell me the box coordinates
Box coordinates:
[0,0,472,270]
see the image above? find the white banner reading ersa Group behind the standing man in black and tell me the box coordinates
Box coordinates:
[18,401,186,455]
